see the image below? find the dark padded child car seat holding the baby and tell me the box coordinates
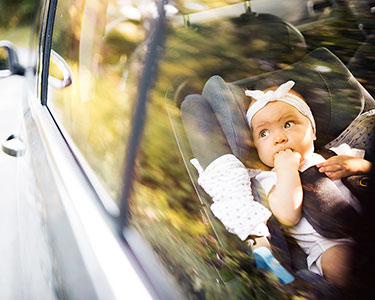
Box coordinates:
[176,48,375,296]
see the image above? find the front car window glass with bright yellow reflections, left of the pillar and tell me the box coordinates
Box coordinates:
[47,0,152,203]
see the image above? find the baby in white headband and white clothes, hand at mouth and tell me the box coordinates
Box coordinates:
[245,81,371,286]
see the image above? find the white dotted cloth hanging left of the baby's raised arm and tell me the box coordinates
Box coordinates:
[192,154,271,240]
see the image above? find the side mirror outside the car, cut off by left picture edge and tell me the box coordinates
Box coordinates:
[0,41,25,78]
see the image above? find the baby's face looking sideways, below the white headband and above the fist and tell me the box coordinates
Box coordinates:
[251,101,315,167]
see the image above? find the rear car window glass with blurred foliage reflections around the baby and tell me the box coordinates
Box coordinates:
[129,0,375,299]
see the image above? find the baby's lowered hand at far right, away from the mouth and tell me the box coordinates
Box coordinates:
[316,155,371,180]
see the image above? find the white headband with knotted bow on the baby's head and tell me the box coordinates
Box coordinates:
[245,80,316,133]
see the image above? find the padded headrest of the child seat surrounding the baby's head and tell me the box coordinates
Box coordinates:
[202,48,375,167]
